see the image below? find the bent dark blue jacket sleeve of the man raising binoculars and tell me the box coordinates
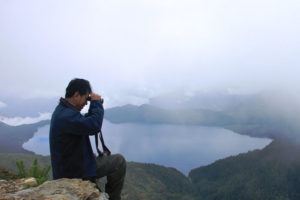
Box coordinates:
[65,100,104,135]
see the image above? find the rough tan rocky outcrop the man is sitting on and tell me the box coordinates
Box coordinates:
[0,178,108,200]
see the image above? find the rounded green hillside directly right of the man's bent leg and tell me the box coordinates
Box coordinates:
[122,162,194,200]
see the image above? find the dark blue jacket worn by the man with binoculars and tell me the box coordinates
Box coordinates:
[49,98,104,179]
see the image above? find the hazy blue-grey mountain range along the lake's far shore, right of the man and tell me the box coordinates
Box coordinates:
[105,92,300,142]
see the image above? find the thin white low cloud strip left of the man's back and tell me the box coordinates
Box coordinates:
[0,113,51,126]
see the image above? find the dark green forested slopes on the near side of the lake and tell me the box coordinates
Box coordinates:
[0,140,300,200]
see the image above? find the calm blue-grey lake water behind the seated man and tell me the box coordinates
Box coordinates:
[23,120,271,175]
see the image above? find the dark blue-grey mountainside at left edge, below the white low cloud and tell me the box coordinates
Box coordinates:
[0,120,49,154]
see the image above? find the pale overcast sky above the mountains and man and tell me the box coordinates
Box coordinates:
[0,0,300,106]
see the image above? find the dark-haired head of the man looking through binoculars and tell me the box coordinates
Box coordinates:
[65,78,92,111]
